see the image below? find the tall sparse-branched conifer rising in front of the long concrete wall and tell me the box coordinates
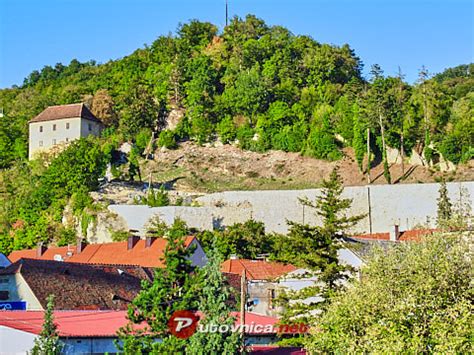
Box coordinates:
[277,167,364,345]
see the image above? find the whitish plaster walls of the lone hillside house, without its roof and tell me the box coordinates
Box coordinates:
[28,117,101,159]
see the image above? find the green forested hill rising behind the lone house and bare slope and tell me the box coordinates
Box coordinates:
[0,15,474,172]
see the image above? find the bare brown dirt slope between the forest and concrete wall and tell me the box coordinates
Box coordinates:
[142,142,474,192]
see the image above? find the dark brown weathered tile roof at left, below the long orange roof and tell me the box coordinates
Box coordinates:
[0,259,153,310]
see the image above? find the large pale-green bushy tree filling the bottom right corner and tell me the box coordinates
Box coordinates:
[306,234,474,354]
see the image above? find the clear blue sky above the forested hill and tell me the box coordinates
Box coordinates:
[0,0,474,87]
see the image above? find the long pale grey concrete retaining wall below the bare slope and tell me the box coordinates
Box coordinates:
[109,182,474,233]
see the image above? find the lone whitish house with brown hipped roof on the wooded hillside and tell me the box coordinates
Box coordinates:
[28,103,103,160]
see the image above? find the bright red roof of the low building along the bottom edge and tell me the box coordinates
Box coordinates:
[0,311,278,338]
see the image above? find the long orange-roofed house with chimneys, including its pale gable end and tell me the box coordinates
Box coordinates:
[8,236,207,268]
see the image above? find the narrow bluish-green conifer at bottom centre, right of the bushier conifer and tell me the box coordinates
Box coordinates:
[186,248,240,355]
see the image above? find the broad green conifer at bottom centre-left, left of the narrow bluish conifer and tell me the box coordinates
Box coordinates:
[118,233,197,354]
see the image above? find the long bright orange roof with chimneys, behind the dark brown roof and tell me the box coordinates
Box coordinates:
[8,236,195,267]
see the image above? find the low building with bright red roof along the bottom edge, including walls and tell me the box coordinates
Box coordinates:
[0,311,299,354]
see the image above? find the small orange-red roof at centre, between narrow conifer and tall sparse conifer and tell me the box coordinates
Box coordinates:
[221,259,297,280]
